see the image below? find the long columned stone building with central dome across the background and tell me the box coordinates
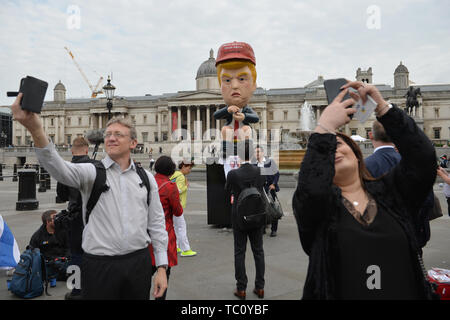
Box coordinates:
[7,50,450,153]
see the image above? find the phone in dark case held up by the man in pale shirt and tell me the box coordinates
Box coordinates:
[7,76,48,113]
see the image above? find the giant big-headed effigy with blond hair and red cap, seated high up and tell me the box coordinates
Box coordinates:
[214,42,259,158]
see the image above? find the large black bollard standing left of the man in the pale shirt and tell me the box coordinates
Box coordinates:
[16,169,39,211]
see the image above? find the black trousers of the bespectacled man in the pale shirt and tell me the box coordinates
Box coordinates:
[81,248,152,300]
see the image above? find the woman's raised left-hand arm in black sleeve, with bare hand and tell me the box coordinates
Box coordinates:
[292,90,356,255]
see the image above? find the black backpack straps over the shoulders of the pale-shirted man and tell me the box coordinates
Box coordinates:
[82,160,151,224]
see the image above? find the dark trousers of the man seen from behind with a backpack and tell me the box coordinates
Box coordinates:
[233,227,265,290]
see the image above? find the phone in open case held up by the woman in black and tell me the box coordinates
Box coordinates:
[323,78,377,123]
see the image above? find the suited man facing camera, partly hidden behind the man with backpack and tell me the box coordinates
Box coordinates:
[254,145,280,237]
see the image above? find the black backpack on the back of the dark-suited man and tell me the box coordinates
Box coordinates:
[236,182,266,231]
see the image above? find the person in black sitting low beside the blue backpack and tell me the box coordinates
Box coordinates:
[30,210,70,281]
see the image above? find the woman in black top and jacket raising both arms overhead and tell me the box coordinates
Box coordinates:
[292,82,436,299]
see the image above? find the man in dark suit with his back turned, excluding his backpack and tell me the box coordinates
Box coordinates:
[225,140,265,300]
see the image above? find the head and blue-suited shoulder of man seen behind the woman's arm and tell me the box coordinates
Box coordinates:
[364,120,401,178]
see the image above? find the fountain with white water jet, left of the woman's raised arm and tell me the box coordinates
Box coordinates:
[278,101,316,169]
